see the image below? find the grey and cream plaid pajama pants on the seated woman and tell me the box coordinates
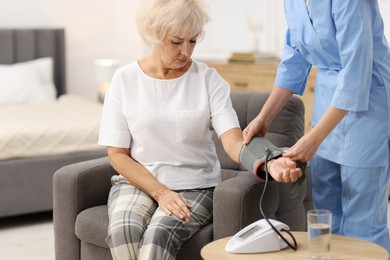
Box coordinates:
[106,175,214,260]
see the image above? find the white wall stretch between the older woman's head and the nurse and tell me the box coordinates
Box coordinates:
[194,0,286,60]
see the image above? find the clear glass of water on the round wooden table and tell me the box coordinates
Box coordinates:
[307,209,332,260]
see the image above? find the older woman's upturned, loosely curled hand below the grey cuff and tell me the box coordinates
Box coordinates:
[267,157,302,182]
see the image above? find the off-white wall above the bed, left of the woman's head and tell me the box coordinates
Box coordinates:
[0,0,144,99]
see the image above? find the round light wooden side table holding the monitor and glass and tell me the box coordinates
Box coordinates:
[201,232,388,260]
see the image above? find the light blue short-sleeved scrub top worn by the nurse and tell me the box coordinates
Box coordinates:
[275,0,390,167]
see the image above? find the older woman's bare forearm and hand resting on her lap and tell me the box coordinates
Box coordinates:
[107,147,190,221]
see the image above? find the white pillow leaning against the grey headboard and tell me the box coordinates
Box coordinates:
[0,57,57,105]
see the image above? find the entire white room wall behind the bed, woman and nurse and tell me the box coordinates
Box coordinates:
[0,0,390,99]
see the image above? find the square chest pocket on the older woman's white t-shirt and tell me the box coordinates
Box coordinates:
[176,110,210,142]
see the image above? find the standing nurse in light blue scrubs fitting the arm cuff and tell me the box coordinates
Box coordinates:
[244,0,390,252]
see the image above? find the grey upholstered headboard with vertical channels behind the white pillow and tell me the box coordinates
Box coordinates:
[0,29,66,96]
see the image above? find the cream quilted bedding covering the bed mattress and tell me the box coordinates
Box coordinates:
[0,95,105,159]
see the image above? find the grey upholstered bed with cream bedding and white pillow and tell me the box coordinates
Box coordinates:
[0,28,106,217]
